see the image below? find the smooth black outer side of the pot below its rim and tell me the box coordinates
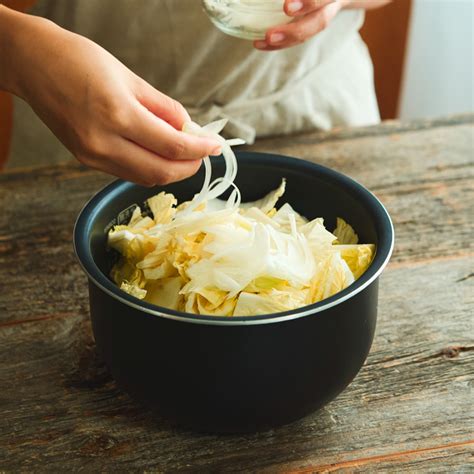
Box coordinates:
[89,280,378,432]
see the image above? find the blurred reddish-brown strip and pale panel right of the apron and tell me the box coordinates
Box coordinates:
[361,0,474,119]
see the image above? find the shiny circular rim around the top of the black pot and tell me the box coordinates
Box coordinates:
[73,152,395,326]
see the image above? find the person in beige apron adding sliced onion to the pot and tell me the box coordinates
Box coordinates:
[0,0,390,186]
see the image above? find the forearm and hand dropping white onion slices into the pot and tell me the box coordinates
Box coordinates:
[0,5,219,185]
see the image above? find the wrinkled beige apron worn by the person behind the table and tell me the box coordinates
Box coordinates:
[10,0,379,166]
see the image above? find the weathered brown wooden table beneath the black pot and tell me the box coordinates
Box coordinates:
[0,116,474,473]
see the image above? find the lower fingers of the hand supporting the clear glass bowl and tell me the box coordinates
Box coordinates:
[254,2,341,51]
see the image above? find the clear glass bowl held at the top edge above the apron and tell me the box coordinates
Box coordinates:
[202,0,293,40]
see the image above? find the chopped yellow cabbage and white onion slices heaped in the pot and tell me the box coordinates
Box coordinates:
[108,121,375,316]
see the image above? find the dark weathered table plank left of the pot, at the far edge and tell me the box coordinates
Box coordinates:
[0,165,111,327]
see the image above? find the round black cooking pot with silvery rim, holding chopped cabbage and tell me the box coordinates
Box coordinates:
[74,152,394,432]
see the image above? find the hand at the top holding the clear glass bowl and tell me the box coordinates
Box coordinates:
[254,0,392,51]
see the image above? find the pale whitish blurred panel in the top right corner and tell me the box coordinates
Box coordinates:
[399,0,474,119]
